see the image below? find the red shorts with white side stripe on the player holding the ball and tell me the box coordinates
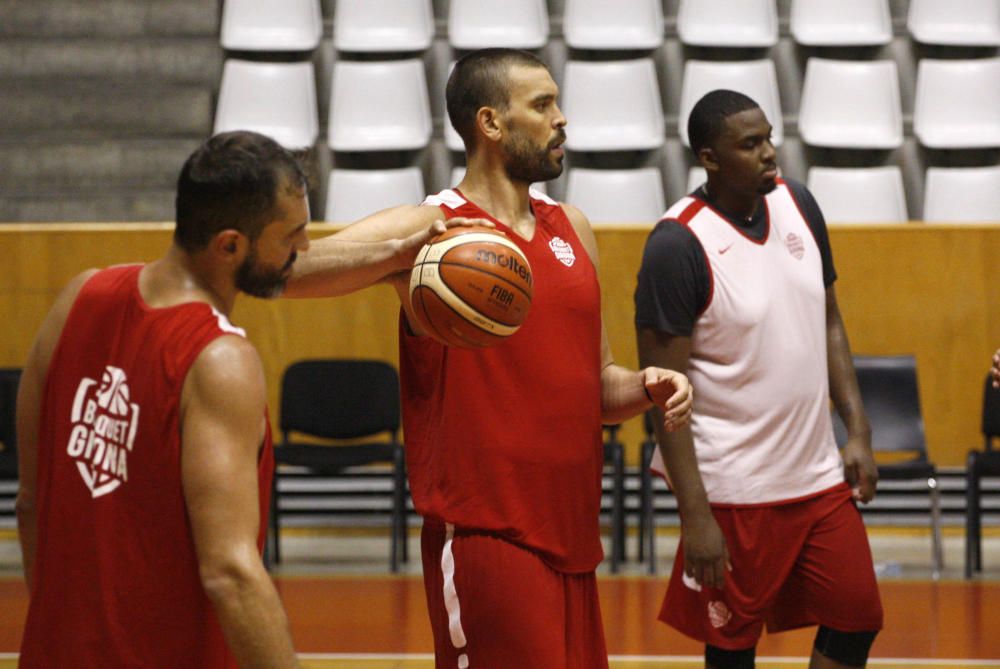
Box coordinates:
[421,520,608,669]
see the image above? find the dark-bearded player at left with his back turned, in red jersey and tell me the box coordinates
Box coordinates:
[17,132,476,669]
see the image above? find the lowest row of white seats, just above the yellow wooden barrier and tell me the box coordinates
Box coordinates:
[324,166,1000,224]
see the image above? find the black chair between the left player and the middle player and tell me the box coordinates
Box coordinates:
[270,359,408,572]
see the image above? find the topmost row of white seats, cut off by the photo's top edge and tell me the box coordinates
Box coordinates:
[221,0,1000,52]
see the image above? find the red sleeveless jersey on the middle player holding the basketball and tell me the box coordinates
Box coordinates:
[400,190,603,573]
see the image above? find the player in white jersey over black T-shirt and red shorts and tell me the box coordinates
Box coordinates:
[635,90,882,669]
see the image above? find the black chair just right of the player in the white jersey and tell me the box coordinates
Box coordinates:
[833,355,944,578]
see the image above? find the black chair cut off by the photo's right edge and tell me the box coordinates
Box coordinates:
[965,375,1000,578]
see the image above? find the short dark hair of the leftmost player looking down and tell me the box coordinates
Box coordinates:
[174,130,307,253]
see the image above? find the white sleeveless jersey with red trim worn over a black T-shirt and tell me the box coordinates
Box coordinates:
[656,180,844,504]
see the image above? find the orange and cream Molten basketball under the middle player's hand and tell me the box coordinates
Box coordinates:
[410,227,532,348]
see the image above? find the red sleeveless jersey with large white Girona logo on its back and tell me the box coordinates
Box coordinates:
[20,265,274,669]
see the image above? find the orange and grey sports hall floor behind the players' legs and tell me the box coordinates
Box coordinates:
[0,528,1000,669]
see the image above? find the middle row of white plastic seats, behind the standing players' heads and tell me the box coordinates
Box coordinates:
[215,58,1000,151]
